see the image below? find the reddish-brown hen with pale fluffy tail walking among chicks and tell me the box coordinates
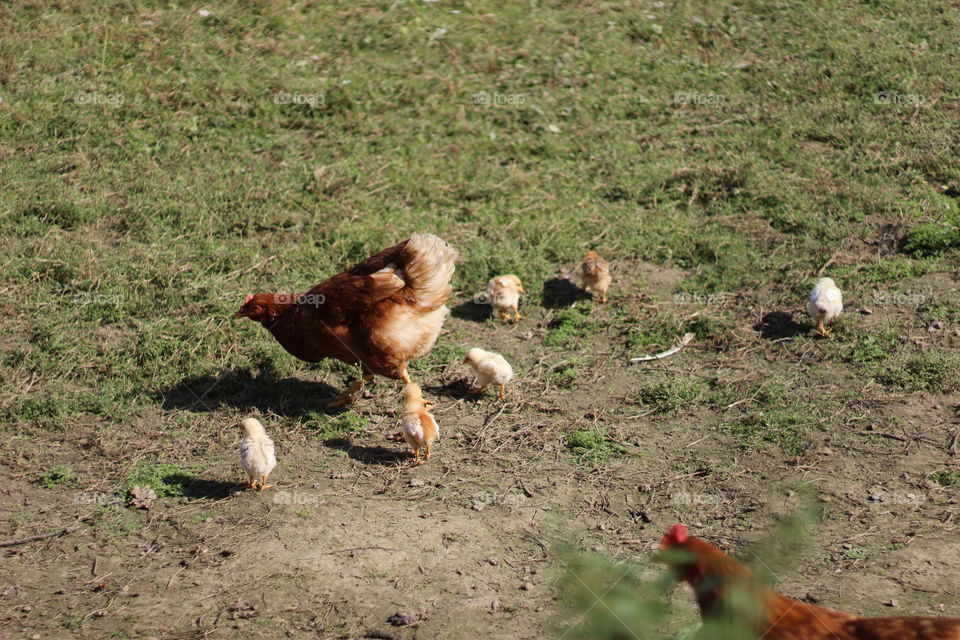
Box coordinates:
[234,233,457,406]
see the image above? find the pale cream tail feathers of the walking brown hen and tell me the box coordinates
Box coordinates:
[403,233,457,308]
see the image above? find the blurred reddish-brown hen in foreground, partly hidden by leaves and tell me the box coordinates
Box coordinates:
[660,524,960,640]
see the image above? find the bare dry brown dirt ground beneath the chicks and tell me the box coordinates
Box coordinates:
[0,264,960,639]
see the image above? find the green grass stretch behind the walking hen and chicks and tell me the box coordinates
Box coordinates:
[0,0,960,436]
